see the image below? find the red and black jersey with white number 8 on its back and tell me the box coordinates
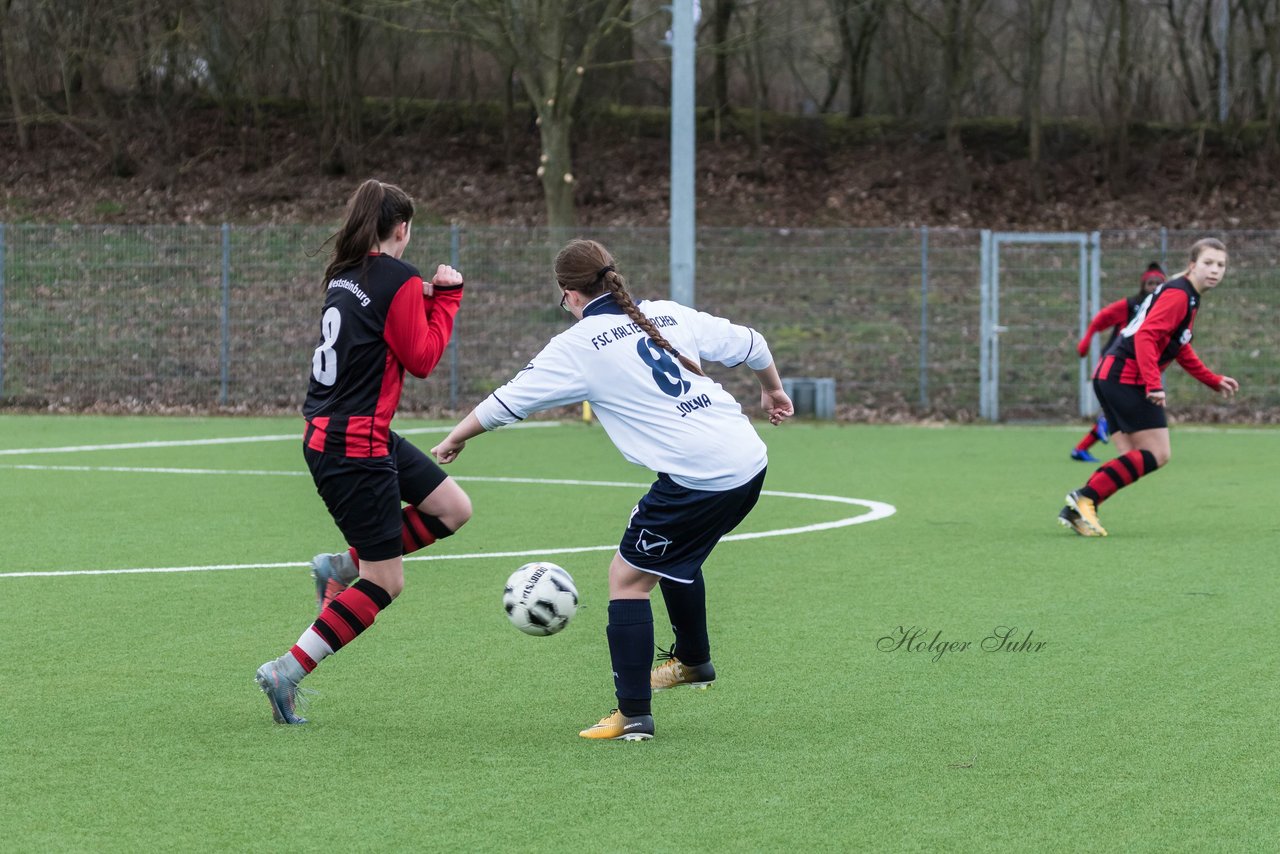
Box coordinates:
[302,252,462,457]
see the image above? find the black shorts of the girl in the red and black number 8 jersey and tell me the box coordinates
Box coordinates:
[302,433,448,561]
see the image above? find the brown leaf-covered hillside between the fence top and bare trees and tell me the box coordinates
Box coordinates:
[0,106,1280,230]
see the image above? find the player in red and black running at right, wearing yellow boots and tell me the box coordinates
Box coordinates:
[1059,237,1240,536]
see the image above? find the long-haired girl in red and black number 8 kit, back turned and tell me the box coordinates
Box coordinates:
[256,179,471,723]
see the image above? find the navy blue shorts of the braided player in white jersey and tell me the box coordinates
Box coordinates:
[618,469,765,584]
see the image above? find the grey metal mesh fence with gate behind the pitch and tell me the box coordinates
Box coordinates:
[0,224,1280,420]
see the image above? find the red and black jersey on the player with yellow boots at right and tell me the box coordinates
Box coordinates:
[1094,277,1222,393]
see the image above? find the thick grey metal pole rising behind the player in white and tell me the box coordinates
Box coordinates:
[671,0,696,306]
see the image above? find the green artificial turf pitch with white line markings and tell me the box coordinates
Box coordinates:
[0,416,1280,851]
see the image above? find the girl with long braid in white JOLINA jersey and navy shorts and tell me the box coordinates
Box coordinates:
[431,239,794,740]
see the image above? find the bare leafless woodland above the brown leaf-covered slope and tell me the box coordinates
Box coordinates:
[10,0,1280,215]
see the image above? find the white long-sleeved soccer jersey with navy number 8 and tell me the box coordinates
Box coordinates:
[475,293,773,492]
